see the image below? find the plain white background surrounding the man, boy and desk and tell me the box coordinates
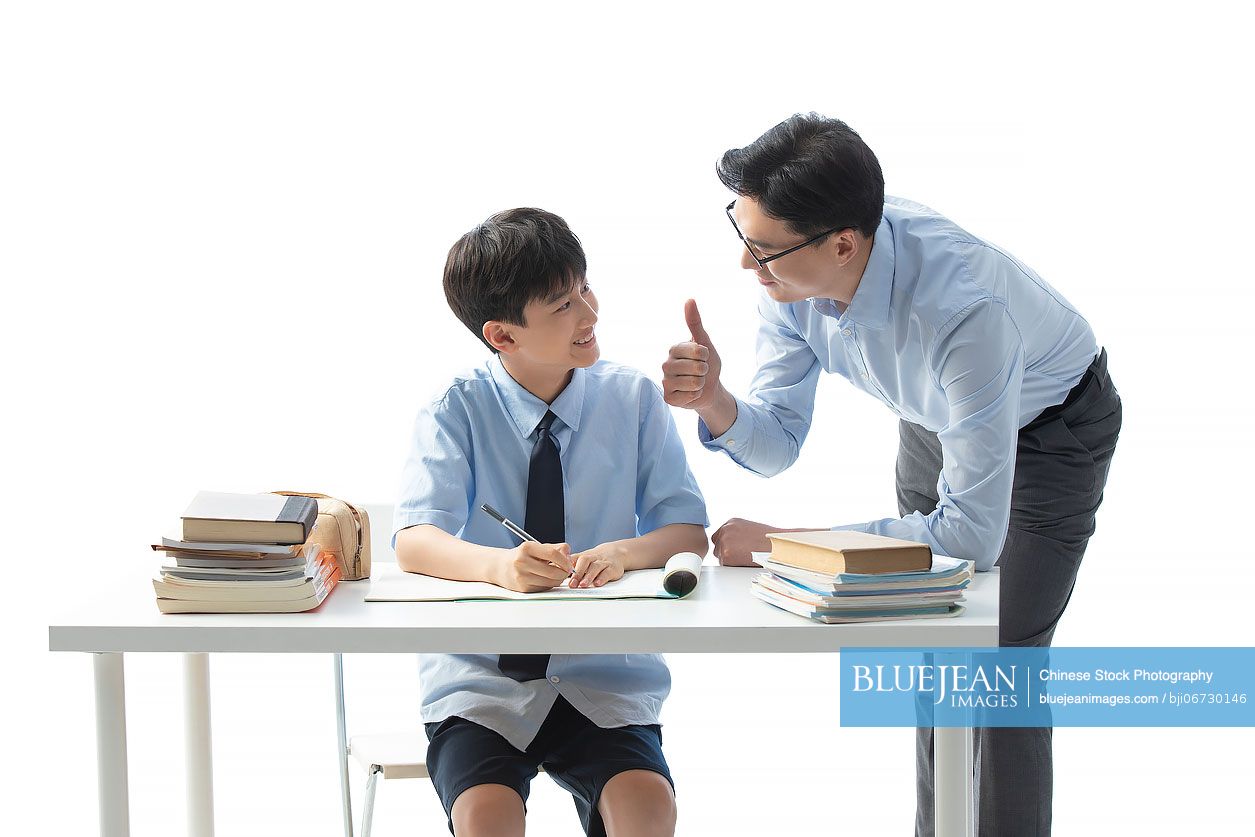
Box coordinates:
[0,3,1255,834]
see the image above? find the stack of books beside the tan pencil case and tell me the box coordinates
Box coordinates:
[153,491,340,614]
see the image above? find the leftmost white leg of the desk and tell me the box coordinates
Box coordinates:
[92,653,131,837]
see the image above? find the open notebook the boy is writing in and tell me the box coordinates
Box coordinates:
[366,552,702,601]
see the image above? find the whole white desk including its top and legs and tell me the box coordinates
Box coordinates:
[49,566,998,837]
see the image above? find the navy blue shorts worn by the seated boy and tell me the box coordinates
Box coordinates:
[424,695,675,837]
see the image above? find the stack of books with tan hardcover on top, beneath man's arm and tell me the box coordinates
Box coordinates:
[752,531,973,624]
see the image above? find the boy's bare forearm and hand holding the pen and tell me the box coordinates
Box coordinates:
[397,523,574,592]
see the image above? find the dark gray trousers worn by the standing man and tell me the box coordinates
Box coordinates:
[896,350,1121,837]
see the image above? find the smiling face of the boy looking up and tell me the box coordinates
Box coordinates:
[503,277,601,371]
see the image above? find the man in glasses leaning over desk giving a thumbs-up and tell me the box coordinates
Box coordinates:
[663,114,1121,837]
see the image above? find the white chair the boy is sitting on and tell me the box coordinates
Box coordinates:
[333,504,542,837]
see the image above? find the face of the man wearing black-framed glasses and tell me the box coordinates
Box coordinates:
[732,196,853,302]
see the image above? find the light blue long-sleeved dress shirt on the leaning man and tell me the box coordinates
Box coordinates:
[698,197,1098,570]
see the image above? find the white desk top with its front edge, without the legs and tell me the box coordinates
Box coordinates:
[48,566,998,654]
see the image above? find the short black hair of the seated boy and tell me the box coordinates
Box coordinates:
[444,207,589,351]
